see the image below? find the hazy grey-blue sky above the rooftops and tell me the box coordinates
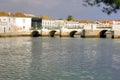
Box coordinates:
[0,0,120,21]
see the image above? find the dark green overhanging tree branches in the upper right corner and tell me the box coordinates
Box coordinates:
[83,0,120,14]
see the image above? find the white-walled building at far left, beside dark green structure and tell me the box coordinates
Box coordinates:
[0,16,31,33]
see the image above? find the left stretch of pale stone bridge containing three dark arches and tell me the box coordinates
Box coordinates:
[31,28,83,37]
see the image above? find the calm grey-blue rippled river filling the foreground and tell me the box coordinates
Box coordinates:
[0,37,120,80]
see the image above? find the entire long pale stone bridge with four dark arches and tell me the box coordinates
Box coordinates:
[31,27,120,38]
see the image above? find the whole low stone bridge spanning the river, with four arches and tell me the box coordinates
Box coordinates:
[31,29,120,38]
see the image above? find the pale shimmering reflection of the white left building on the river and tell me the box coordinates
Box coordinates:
[0,38,31,80]
